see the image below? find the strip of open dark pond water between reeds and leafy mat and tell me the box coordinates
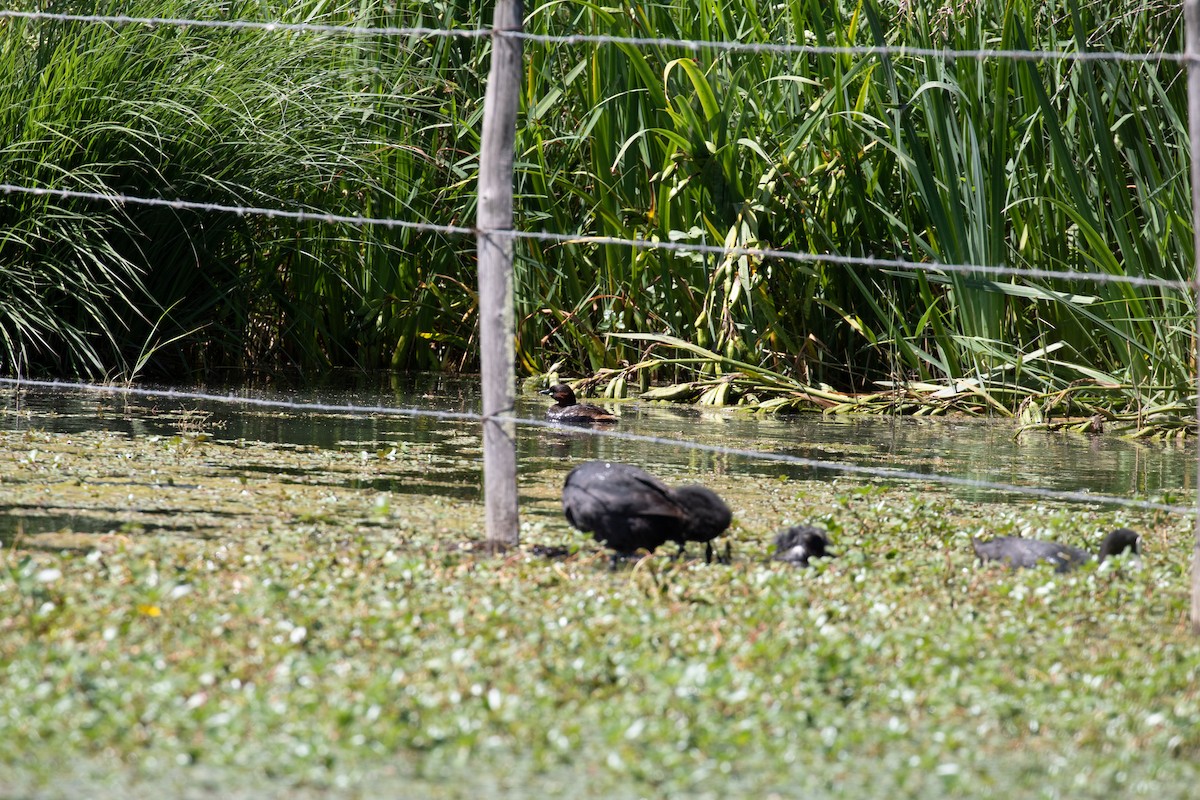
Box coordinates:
[0,375,1196,513]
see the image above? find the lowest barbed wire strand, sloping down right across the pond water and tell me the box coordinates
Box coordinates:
[0,378,1195,515]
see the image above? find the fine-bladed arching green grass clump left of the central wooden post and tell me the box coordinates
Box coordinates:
[0,1,463,374]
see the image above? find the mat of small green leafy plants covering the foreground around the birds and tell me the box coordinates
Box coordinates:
[0,419,1200,798]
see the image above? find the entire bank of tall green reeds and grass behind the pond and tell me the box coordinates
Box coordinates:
[0,0,1195,426]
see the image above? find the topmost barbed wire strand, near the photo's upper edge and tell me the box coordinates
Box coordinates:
[0,10,1190,64]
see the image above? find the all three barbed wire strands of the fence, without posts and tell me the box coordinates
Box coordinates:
[0,10,1200,537]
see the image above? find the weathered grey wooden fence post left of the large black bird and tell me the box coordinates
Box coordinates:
[476,0,521,551]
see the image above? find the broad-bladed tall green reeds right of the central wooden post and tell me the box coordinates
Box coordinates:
[513,2,1190,412]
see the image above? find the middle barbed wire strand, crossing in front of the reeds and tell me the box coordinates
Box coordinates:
[0,184,1195,291]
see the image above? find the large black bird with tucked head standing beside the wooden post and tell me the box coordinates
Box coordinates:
[563,461,733,565]
